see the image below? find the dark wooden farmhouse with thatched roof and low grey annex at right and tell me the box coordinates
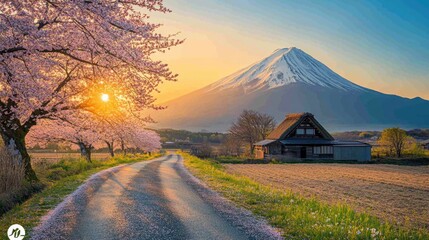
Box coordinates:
[255,113,371,161]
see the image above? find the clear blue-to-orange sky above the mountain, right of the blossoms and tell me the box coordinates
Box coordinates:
[152,0,429,102]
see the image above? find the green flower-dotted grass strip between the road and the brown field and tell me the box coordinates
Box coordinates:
[180,153,429,239]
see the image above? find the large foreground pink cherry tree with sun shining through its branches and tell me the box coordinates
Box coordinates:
[0,0,182,180]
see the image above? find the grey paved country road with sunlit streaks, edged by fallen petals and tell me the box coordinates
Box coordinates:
[35,155,280,240]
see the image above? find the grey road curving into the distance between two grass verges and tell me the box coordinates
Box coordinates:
[32,155,281,240]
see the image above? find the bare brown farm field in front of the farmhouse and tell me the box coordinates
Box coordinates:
[225,164,429,229]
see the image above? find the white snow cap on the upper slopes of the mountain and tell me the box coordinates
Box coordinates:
[209,47,366,92]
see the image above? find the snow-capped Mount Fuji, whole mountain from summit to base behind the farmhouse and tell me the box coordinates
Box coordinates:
[151,47,429,132]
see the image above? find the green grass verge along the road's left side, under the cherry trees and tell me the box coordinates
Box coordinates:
[0,154,161,239]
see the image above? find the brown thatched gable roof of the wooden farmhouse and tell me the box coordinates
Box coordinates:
[267,112,334,140]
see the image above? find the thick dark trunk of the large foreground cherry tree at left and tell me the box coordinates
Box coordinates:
[1,128,38,181]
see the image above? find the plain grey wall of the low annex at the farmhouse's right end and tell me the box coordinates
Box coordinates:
[334,146,371,161]
